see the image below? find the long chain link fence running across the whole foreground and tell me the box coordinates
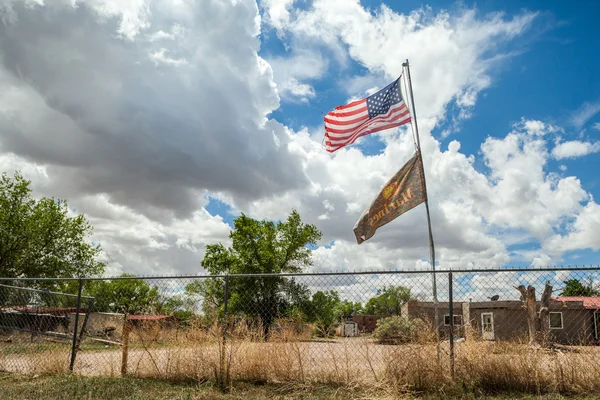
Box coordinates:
[0,267,600,392]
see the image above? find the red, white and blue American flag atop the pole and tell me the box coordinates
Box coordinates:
[325,78,410,153]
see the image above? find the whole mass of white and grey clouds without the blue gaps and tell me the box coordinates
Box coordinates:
[0,0,590,282]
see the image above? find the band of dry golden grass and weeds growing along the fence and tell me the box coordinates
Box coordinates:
[0,322,600,397]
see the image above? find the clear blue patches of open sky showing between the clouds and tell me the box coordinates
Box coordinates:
[207,1,600,267]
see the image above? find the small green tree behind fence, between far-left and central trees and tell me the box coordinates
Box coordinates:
[86,274,159,314]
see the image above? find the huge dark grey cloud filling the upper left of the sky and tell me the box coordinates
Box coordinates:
[0,0,306,216]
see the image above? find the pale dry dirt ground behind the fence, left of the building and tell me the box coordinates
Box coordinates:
[0,338,404,378]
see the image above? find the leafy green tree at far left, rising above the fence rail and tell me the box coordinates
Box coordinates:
[0,173,104,278]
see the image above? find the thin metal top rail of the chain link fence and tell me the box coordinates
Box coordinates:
[0,265,600,282]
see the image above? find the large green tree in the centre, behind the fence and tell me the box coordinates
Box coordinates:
[197,210,321,336]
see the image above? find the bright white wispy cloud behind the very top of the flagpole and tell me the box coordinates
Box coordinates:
[270,0,536,128]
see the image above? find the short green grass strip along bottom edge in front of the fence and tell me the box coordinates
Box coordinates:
[0,374,595,400]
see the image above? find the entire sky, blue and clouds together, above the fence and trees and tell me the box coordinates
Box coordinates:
[0,0,600,274]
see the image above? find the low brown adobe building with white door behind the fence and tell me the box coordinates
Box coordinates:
[401,297,600,344]
